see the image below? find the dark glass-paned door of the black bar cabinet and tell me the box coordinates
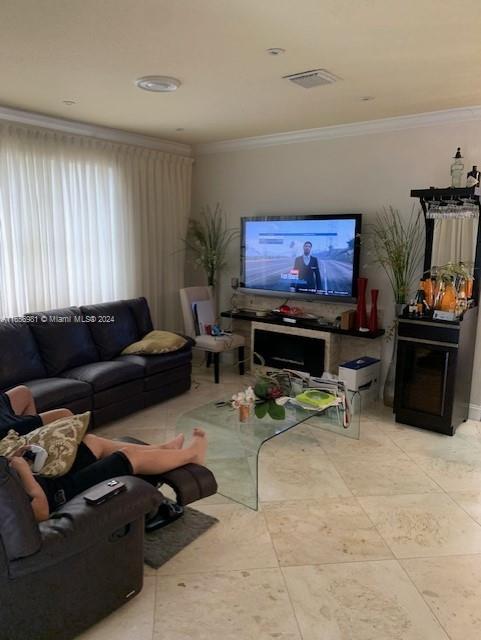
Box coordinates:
[394,337,457,434]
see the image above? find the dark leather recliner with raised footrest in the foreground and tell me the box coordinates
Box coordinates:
[0,457,217,640]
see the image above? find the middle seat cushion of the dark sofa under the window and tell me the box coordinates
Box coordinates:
[25,378,92,413]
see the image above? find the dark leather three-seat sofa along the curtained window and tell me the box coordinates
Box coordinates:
[0,298,193,426]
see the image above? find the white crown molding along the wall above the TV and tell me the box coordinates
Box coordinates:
[194,106,481,156]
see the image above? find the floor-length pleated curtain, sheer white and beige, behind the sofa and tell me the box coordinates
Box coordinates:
[0,123,192,329]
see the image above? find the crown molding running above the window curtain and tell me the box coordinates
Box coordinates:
[0,106,192,157]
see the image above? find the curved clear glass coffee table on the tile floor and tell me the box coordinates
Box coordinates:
[176,392,361,510]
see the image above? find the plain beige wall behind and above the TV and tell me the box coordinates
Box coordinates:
[188,121,481,415]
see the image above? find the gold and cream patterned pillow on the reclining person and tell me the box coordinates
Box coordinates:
[0,411,90,478]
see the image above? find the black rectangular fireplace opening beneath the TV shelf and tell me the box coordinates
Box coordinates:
[253,329,325,376]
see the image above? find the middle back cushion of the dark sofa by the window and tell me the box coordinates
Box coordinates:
[28,307,99,376]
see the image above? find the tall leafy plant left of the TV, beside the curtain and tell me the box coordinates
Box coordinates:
[184,203,239,286]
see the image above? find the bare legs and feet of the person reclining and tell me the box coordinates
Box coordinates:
[83,429,207,475]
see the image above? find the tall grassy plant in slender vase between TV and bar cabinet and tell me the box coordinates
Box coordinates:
[370,207,424,407]
